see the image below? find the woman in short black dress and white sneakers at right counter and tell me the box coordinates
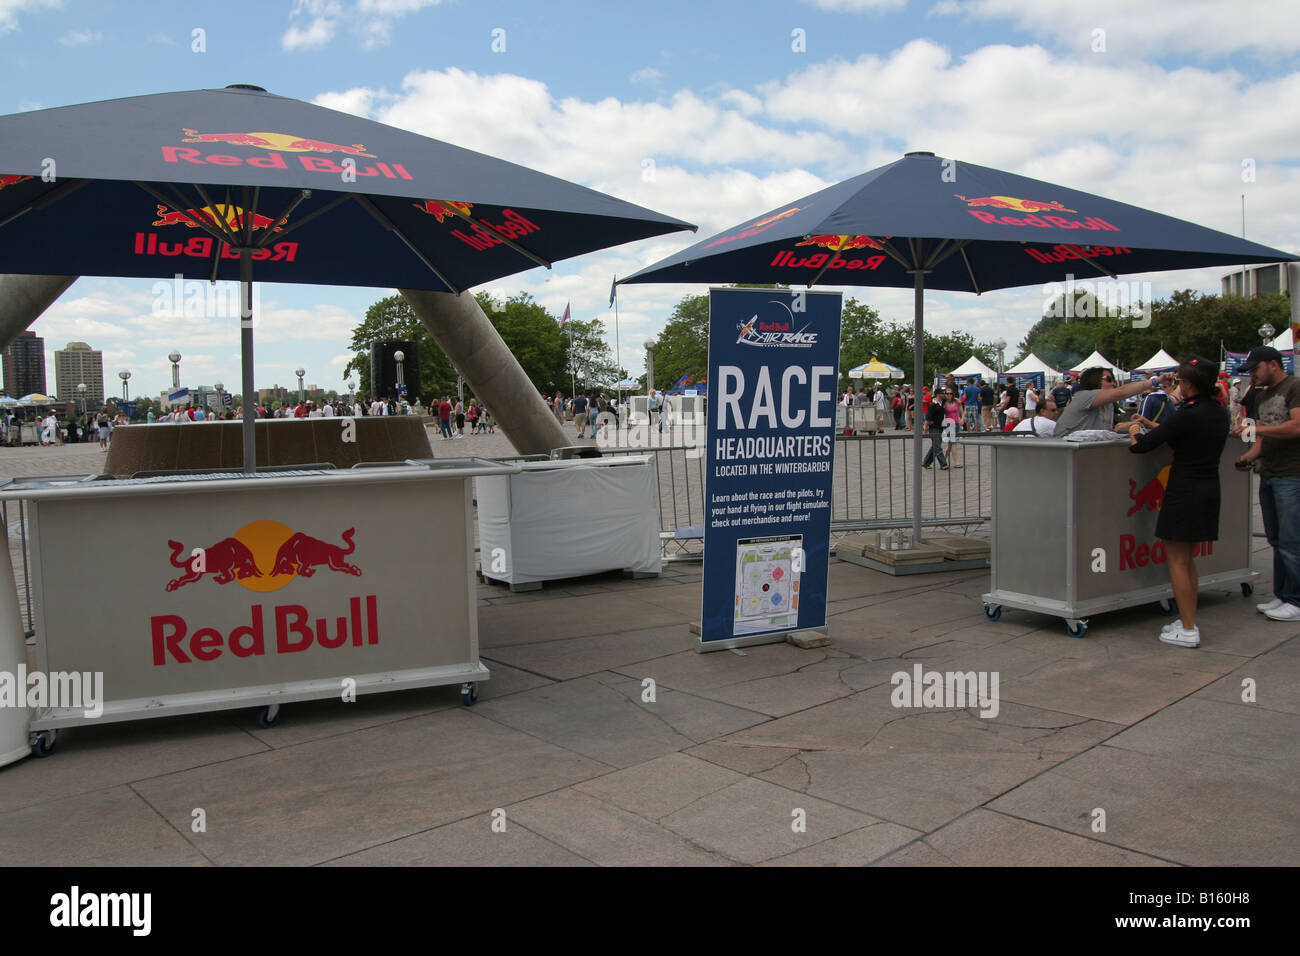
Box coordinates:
[1128,356,1231,648]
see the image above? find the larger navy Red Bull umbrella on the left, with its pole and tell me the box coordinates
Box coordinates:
[0,86,693,471]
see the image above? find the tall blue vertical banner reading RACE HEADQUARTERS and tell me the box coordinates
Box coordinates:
[699,289,841,650]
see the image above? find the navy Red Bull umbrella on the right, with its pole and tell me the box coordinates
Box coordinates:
[619,152,1300,541]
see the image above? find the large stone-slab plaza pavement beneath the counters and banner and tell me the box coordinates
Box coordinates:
[0,432,1300,866]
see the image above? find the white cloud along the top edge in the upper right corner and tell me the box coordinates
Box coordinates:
[933,0,1300,59]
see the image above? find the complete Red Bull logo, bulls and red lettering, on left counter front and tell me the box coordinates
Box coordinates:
[150,520,380,666]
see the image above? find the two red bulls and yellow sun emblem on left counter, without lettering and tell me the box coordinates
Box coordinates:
[166,520,361,592]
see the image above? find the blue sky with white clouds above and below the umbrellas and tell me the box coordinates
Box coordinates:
[0,0,1300,394]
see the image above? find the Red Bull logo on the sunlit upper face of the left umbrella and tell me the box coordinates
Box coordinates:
[163,127,415,179]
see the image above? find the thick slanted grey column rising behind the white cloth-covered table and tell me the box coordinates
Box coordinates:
[399,289,573,455]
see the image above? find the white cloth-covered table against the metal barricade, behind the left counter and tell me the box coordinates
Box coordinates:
[475,458,663,584]
